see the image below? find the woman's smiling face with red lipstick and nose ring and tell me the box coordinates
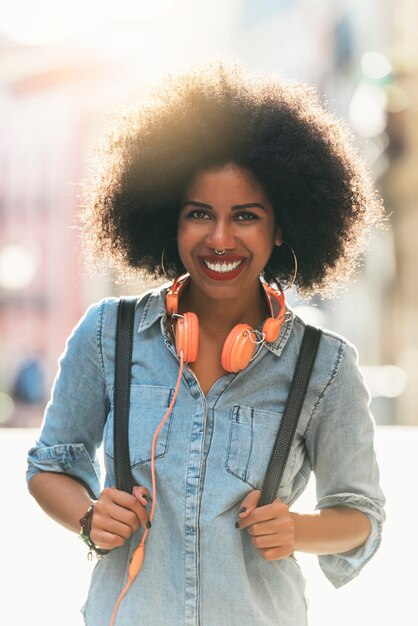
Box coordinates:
[177,164,281,299]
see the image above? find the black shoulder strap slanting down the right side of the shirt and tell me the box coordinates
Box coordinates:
[258,326,321,506]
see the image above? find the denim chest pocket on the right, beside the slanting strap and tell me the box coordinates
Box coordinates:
[226,405,292,489]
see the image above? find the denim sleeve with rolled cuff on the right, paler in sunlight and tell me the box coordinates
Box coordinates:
[306,342,385,587]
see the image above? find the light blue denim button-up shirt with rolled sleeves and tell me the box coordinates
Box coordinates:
[27,287,384,626]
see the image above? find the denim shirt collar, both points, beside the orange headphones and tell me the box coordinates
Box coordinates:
[138,283,295,356]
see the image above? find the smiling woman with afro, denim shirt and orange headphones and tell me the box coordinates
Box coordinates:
[28,67,384,626]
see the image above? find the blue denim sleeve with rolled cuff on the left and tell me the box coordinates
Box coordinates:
[26,301,108,498]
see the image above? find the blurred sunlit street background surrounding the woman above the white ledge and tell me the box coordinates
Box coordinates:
[0,0,418,626]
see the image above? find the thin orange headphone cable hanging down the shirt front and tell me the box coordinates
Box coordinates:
[110,351,184,626]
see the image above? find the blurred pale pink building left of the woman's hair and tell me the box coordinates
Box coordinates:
[0,46,113,425]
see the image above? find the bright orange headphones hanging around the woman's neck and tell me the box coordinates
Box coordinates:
[165,274,285,372]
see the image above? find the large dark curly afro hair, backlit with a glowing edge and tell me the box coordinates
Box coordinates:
[82,63,383,295]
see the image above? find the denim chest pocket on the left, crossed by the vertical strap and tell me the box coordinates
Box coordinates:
[104,385,174,467]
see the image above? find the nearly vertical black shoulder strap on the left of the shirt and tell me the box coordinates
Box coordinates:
[113,298,136,493]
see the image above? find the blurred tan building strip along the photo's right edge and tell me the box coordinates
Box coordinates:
[382,0,418,424]
